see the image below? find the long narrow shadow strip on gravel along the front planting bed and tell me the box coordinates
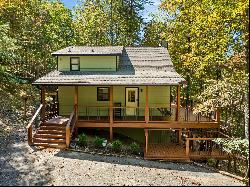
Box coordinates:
[54,150,214,173]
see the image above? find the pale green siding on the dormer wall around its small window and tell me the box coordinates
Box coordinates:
[58,56,119,71]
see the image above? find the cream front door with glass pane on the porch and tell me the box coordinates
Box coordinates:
[126,88,139,116]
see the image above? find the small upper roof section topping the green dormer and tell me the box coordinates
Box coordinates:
[52,46,123,56]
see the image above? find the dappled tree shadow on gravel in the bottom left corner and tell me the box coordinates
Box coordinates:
[0,143,51,186]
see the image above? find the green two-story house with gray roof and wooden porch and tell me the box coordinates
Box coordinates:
[28,46,226,159]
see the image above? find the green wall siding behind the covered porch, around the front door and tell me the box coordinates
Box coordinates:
[58,86,170,116]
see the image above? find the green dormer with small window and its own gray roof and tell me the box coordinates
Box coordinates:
[52,46,123,71]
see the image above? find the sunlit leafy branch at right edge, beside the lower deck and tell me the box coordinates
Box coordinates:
[213,138,249,159]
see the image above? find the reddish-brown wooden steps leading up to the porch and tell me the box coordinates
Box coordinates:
[33,117,68,149]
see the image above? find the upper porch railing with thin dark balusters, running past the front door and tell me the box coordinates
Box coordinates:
[75,105,216,123]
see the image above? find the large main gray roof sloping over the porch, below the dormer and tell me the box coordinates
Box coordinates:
[34,47,185,85]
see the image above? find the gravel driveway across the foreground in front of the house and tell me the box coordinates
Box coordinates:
[0,120,244,186]
